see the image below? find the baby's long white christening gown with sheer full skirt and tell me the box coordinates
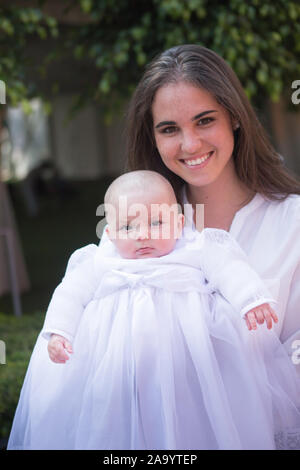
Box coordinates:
[8,229,300,450]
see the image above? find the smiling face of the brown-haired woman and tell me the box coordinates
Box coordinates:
[152,82,235,187]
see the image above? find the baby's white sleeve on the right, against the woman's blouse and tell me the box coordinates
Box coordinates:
[201,229,275,316]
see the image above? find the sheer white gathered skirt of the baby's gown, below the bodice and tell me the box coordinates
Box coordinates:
[8,287,300,450]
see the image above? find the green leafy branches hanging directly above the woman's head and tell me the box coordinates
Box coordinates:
[69,0,300,108]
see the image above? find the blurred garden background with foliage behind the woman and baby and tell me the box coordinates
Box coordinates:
[0,0,300,448]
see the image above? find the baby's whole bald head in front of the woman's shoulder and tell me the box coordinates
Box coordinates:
[104,170,184,259]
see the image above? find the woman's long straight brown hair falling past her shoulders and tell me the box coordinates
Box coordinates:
[126,45,300,200]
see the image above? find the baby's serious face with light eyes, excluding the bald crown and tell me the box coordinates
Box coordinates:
[106,188,184,259]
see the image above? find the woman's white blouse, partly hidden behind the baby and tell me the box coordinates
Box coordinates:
[183,191,300,362]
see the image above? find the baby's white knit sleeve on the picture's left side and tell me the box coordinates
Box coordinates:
[42,245,98,341]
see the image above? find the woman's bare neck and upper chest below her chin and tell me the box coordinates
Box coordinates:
[187,167,254,231]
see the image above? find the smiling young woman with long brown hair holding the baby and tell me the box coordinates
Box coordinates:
[126,45,300,372]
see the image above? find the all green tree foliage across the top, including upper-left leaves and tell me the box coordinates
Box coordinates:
[0,0,300,108]
